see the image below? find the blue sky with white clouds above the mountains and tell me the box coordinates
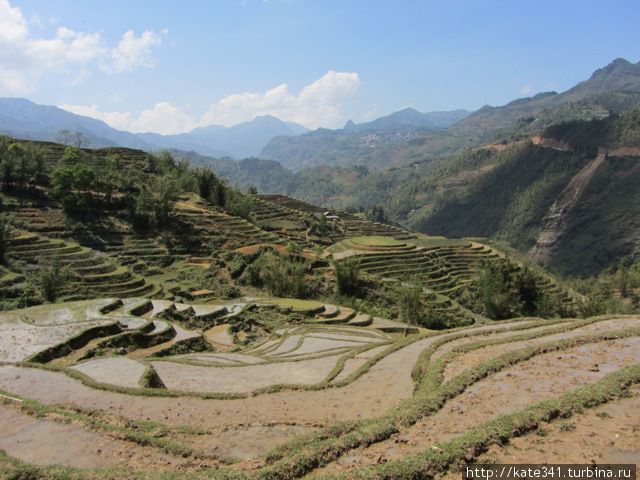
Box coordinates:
[0,0,640,134]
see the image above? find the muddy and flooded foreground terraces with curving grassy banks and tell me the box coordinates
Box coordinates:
[0,299,640,479]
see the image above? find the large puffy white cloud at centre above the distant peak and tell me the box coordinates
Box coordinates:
[200,70,360,128]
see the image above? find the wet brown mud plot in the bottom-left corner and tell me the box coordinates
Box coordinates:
[0,404,194,470]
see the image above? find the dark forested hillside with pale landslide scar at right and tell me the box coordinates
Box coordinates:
[412,110,640,274]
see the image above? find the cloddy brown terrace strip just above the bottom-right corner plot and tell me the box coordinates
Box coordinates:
[316,338,640,475]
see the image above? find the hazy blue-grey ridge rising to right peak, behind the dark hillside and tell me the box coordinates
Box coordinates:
[260,59,640,170]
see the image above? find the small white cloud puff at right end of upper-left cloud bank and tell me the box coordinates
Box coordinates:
[102,30,167,73]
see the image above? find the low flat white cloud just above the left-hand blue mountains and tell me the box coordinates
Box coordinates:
[60,102,198,135]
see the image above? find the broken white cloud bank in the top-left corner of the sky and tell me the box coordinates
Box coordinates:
[0,0,166,93]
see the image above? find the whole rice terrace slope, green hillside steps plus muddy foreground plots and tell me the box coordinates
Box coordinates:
[0,144,640,480]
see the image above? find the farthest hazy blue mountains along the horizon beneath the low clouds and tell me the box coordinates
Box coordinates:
[0,98,469,161]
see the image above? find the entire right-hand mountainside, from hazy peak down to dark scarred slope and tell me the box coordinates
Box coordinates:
[180,59,640,275]
